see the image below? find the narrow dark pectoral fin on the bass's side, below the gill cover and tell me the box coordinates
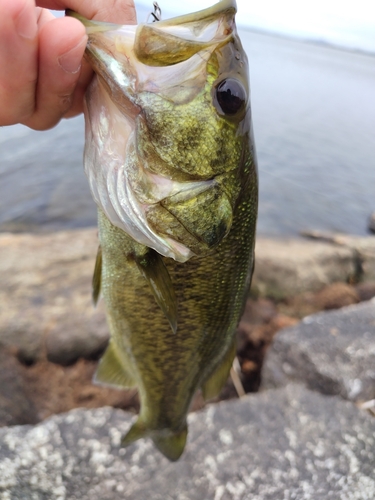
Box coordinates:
[135,248,177,333]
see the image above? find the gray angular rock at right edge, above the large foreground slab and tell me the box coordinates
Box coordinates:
[261,300,375,401]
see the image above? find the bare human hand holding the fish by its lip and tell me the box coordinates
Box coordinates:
[0,0,136,130]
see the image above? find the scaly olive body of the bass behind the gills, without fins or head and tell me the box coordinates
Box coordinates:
[99,140,257,458]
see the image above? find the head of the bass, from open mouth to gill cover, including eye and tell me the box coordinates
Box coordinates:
[69,0,251,262]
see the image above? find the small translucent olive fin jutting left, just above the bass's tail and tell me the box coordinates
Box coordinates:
[94,342,136,389]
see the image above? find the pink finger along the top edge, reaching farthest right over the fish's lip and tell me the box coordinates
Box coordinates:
[36,0,137,24]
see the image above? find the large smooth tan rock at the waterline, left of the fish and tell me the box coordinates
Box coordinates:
[0,229,108,364]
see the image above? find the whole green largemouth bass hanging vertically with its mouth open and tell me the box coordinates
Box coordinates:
[68,0,258,460]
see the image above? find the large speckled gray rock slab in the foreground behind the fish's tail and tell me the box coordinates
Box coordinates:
[0,385,375,500]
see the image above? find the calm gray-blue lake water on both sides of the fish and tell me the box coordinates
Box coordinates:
[0,30,375,235]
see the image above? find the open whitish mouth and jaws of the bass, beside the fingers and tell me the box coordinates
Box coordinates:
[66,0,237,108]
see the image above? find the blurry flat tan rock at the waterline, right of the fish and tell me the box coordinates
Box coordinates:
[252,237,357,299]
